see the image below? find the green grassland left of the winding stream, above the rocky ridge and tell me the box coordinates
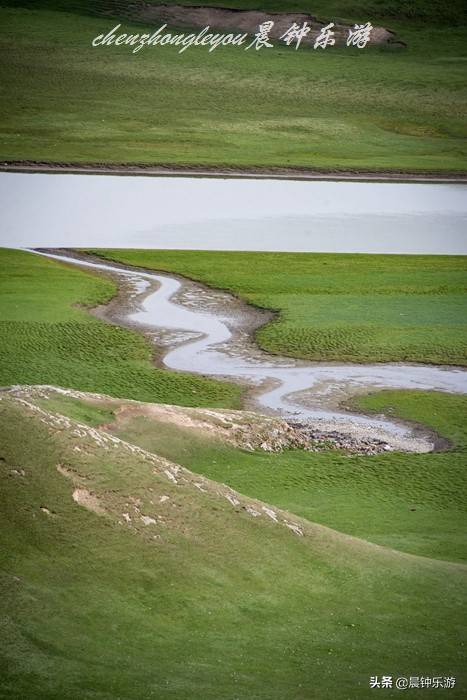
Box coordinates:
[0,249,241,407]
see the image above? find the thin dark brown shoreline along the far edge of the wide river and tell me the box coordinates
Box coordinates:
[0,160,467,184]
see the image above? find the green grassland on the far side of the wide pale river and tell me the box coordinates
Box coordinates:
[0,0,467,172]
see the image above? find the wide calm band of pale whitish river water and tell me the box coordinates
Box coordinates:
[0,173,467,255]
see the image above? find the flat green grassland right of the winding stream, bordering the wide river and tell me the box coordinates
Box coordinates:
[93,249,467,365]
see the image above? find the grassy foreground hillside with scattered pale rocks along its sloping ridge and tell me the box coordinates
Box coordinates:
[0,396,467,700]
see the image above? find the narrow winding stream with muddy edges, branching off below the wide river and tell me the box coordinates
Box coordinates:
[33,251,467,451]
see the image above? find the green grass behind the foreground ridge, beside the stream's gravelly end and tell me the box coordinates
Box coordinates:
[105,391,467,562]
